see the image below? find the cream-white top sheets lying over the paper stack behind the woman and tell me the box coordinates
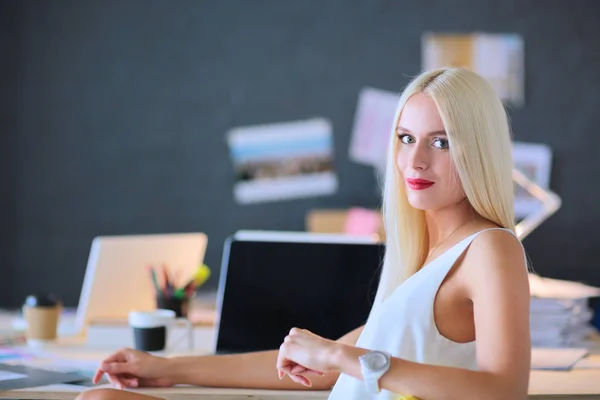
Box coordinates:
[529,273,600,299]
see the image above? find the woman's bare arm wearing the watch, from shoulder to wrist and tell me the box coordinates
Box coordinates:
[331,231,531,400]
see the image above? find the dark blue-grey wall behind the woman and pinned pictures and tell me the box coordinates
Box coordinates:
[2,0,600,305]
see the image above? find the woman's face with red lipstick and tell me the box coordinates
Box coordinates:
[396,93,465,210]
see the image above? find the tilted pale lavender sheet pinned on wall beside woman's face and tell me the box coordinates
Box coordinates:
[349,87,400,169]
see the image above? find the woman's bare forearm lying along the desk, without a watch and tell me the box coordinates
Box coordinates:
[166,326,363,390]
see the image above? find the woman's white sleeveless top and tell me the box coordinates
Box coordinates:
[329,228,514,400]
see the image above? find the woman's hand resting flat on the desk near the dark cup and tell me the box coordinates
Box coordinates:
[93,349,175,389]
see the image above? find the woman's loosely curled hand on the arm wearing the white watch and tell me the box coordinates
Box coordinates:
[277,328,343,387]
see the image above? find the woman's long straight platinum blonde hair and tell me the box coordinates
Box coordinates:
[375,68,515,305]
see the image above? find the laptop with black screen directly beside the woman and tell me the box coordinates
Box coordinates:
[214,231,384,354]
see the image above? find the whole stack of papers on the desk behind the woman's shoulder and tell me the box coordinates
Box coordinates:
[529,274,600,348]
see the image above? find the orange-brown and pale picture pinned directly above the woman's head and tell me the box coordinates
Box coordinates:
[422,32,525,107]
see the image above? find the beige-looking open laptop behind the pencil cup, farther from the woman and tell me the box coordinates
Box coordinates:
[75,232,208,332]
